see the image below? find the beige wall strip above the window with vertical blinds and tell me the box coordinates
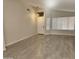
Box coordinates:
[45,10,75,18]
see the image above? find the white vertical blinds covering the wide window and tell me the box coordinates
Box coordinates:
[46,17,75,30]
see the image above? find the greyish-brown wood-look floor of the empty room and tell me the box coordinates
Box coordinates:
[4,35,75,59]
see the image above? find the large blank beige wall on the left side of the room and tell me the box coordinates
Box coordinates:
[4,0,37,45]
